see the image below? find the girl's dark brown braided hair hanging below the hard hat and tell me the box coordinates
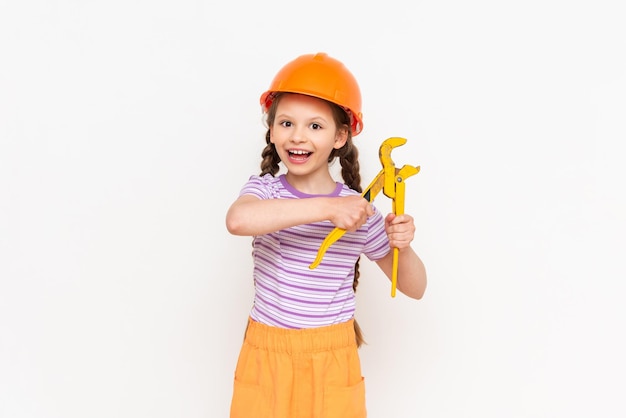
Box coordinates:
[261,93,365,347]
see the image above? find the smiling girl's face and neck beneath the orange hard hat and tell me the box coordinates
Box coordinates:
[270,94,348,186]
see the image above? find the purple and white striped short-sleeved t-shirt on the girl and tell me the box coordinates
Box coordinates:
[240,174,389,329]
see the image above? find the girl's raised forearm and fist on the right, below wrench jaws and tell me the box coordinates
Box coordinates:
[376,214,426,299]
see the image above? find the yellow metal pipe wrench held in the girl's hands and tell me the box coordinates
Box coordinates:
[309,137,420,297]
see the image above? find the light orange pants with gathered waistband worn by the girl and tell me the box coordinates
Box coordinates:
[230,319,367,418]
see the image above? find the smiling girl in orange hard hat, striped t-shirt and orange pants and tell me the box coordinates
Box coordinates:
[226,53,426,418]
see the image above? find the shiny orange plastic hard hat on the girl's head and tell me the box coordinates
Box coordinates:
[260,52,363,136]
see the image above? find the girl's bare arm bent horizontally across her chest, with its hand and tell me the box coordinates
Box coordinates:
[226,195,373,236]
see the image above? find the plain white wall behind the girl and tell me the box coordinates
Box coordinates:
[0,0,626,418]
